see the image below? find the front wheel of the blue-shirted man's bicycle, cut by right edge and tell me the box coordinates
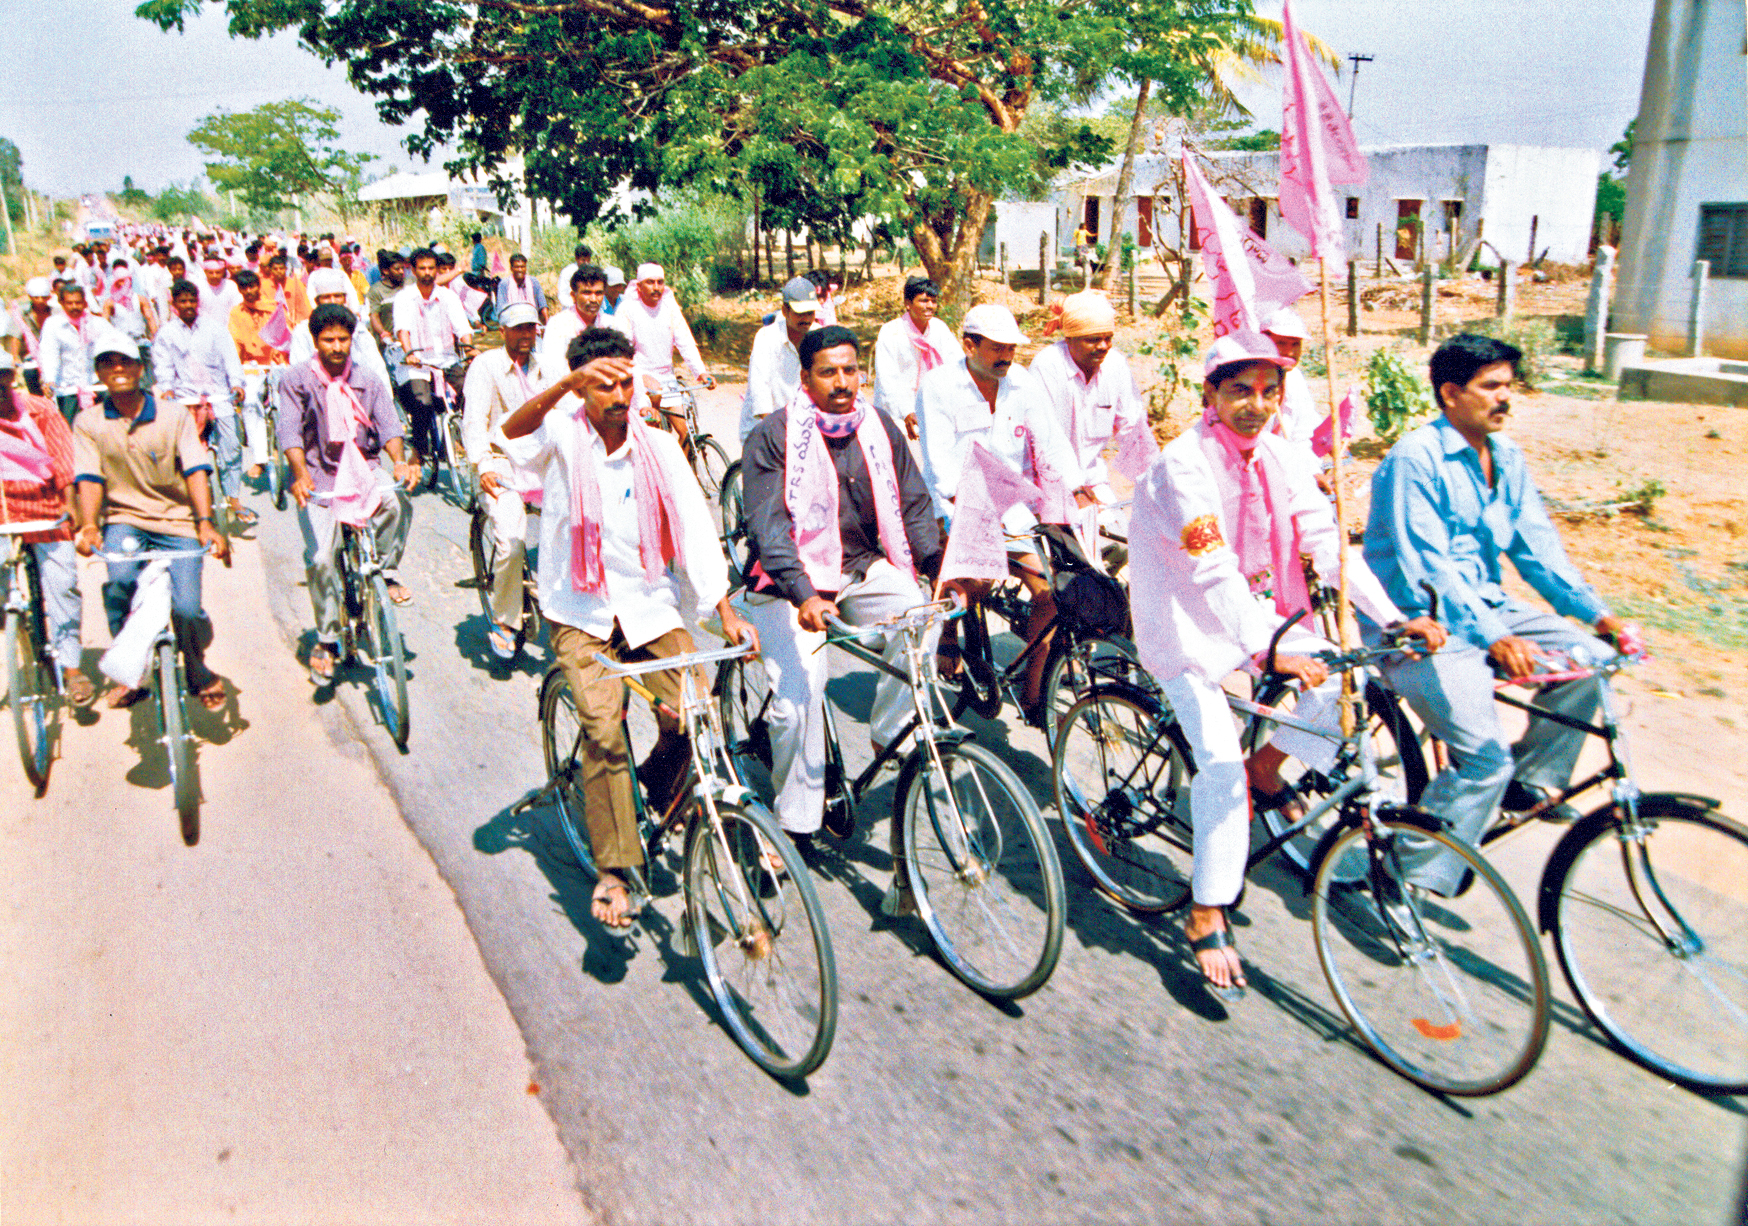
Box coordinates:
[1542,796,1748,1095]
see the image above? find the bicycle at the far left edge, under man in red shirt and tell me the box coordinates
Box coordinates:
[0,516,66,796]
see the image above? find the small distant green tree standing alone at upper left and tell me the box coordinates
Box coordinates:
[189,98,376,212]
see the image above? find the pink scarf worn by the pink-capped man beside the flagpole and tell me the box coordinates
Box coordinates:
[1201,406,1311,617]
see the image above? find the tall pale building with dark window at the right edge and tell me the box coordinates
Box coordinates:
[1610,0,1748,359]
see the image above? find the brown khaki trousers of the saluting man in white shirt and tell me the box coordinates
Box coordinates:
[551,623,703,871]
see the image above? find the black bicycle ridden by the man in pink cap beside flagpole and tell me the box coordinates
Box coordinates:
[1052,614,1550,1095]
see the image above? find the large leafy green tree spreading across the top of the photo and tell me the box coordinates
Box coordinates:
[136,0,1250,304]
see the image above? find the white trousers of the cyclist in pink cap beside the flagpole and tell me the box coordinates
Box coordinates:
[1159,626,1341,906]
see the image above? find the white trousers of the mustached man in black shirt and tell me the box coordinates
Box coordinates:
[741,558,940,834]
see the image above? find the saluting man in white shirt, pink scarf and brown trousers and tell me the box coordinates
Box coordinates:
[493,327,757,929]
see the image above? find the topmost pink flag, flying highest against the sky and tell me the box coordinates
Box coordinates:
[1281,0,1367,261]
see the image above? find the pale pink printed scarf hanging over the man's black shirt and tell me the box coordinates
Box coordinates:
[783,390,916,591]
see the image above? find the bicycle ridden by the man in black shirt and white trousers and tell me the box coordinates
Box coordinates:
[715,602,1065,1000]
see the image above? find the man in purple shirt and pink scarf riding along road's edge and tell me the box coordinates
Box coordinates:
[280,303,418,686]
